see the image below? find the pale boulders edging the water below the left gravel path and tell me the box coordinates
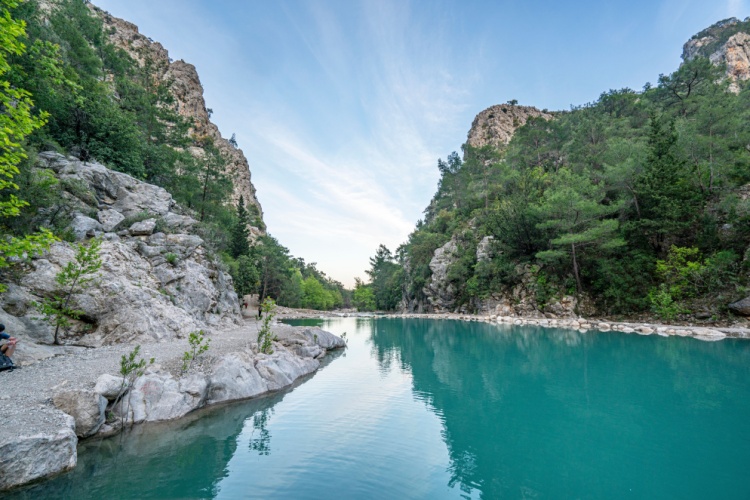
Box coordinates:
[0,326,346,491]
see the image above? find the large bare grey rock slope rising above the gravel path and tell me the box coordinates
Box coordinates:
[0,153,240,352]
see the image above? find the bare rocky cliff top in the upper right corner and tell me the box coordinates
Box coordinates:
[682,17,750,92]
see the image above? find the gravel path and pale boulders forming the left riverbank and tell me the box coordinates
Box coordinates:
[0,320,345,491]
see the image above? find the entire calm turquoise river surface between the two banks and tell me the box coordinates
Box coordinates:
[10,318,750,499]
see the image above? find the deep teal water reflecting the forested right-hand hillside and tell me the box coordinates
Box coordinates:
[371,320,750,498]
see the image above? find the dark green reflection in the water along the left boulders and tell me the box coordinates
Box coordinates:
[3,376,302,500]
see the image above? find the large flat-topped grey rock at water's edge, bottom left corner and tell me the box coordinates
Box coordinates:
[0,416,78,491]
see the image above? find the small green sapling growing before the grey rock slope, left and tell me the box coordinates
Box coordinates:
[36,238,102,344]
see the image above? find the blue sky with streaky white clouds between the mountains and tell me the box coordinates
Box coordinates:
[94,0,750,286]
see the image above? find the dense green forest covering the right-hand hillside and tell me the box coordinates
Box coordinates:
[362,22,750,319]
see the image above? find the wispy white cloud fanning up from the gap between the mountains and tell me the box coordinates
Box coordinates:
[244,1,467,284]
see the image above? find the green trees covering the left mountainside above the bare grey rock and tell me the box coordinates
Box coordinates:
[0,0,350,309]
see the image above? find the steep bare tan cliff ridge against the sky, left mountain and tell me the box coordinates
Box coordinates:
[91,5,265,235]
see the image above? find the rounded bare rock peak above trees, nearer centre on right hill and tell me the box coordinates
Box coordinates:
[466,104,552,152]
